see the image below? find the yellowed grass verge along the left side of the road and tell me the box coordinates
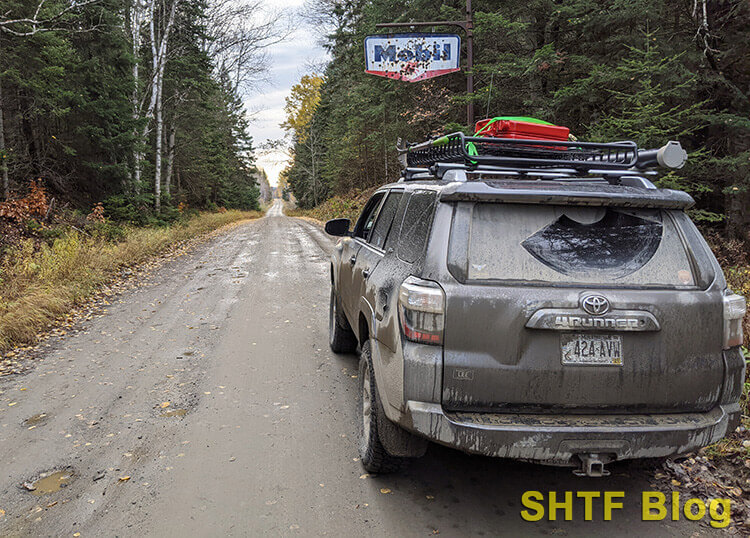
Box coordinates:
[0,207,261,351]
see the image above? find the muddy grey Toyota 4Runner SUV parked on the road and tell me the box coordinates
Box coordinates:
[326,134,745,476]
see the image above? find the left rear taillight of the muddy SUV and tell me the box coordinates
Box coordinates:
[398,276,445,345]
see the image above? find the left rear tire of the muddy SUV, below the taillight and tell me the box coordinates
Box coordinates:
[359,341,409,474]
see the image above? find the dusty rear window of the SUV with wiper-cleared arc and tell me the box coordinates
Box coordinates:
[458,203,695,286]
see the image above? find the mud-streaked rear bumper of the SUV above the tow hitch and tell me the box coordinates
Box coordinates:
[405,401,740,465]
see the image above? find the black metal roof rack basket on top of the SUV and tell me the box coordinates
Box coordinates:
[397,132,687,179]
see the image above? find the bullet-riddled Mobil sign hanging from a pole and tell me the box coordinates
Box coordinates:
[365,34,461,82]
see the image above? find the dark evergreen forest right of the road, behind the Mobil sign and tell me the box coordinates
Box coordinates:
[284,0,750,243]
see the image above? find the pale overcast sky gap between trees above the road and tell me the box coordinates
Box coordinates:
[245,0,326,185]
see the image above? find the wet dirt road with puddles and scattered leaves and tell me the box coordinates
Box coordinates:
[0,199,705,537]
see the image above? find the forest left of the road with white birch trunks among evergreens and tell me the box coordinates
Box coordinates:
[0,0,284,224]
